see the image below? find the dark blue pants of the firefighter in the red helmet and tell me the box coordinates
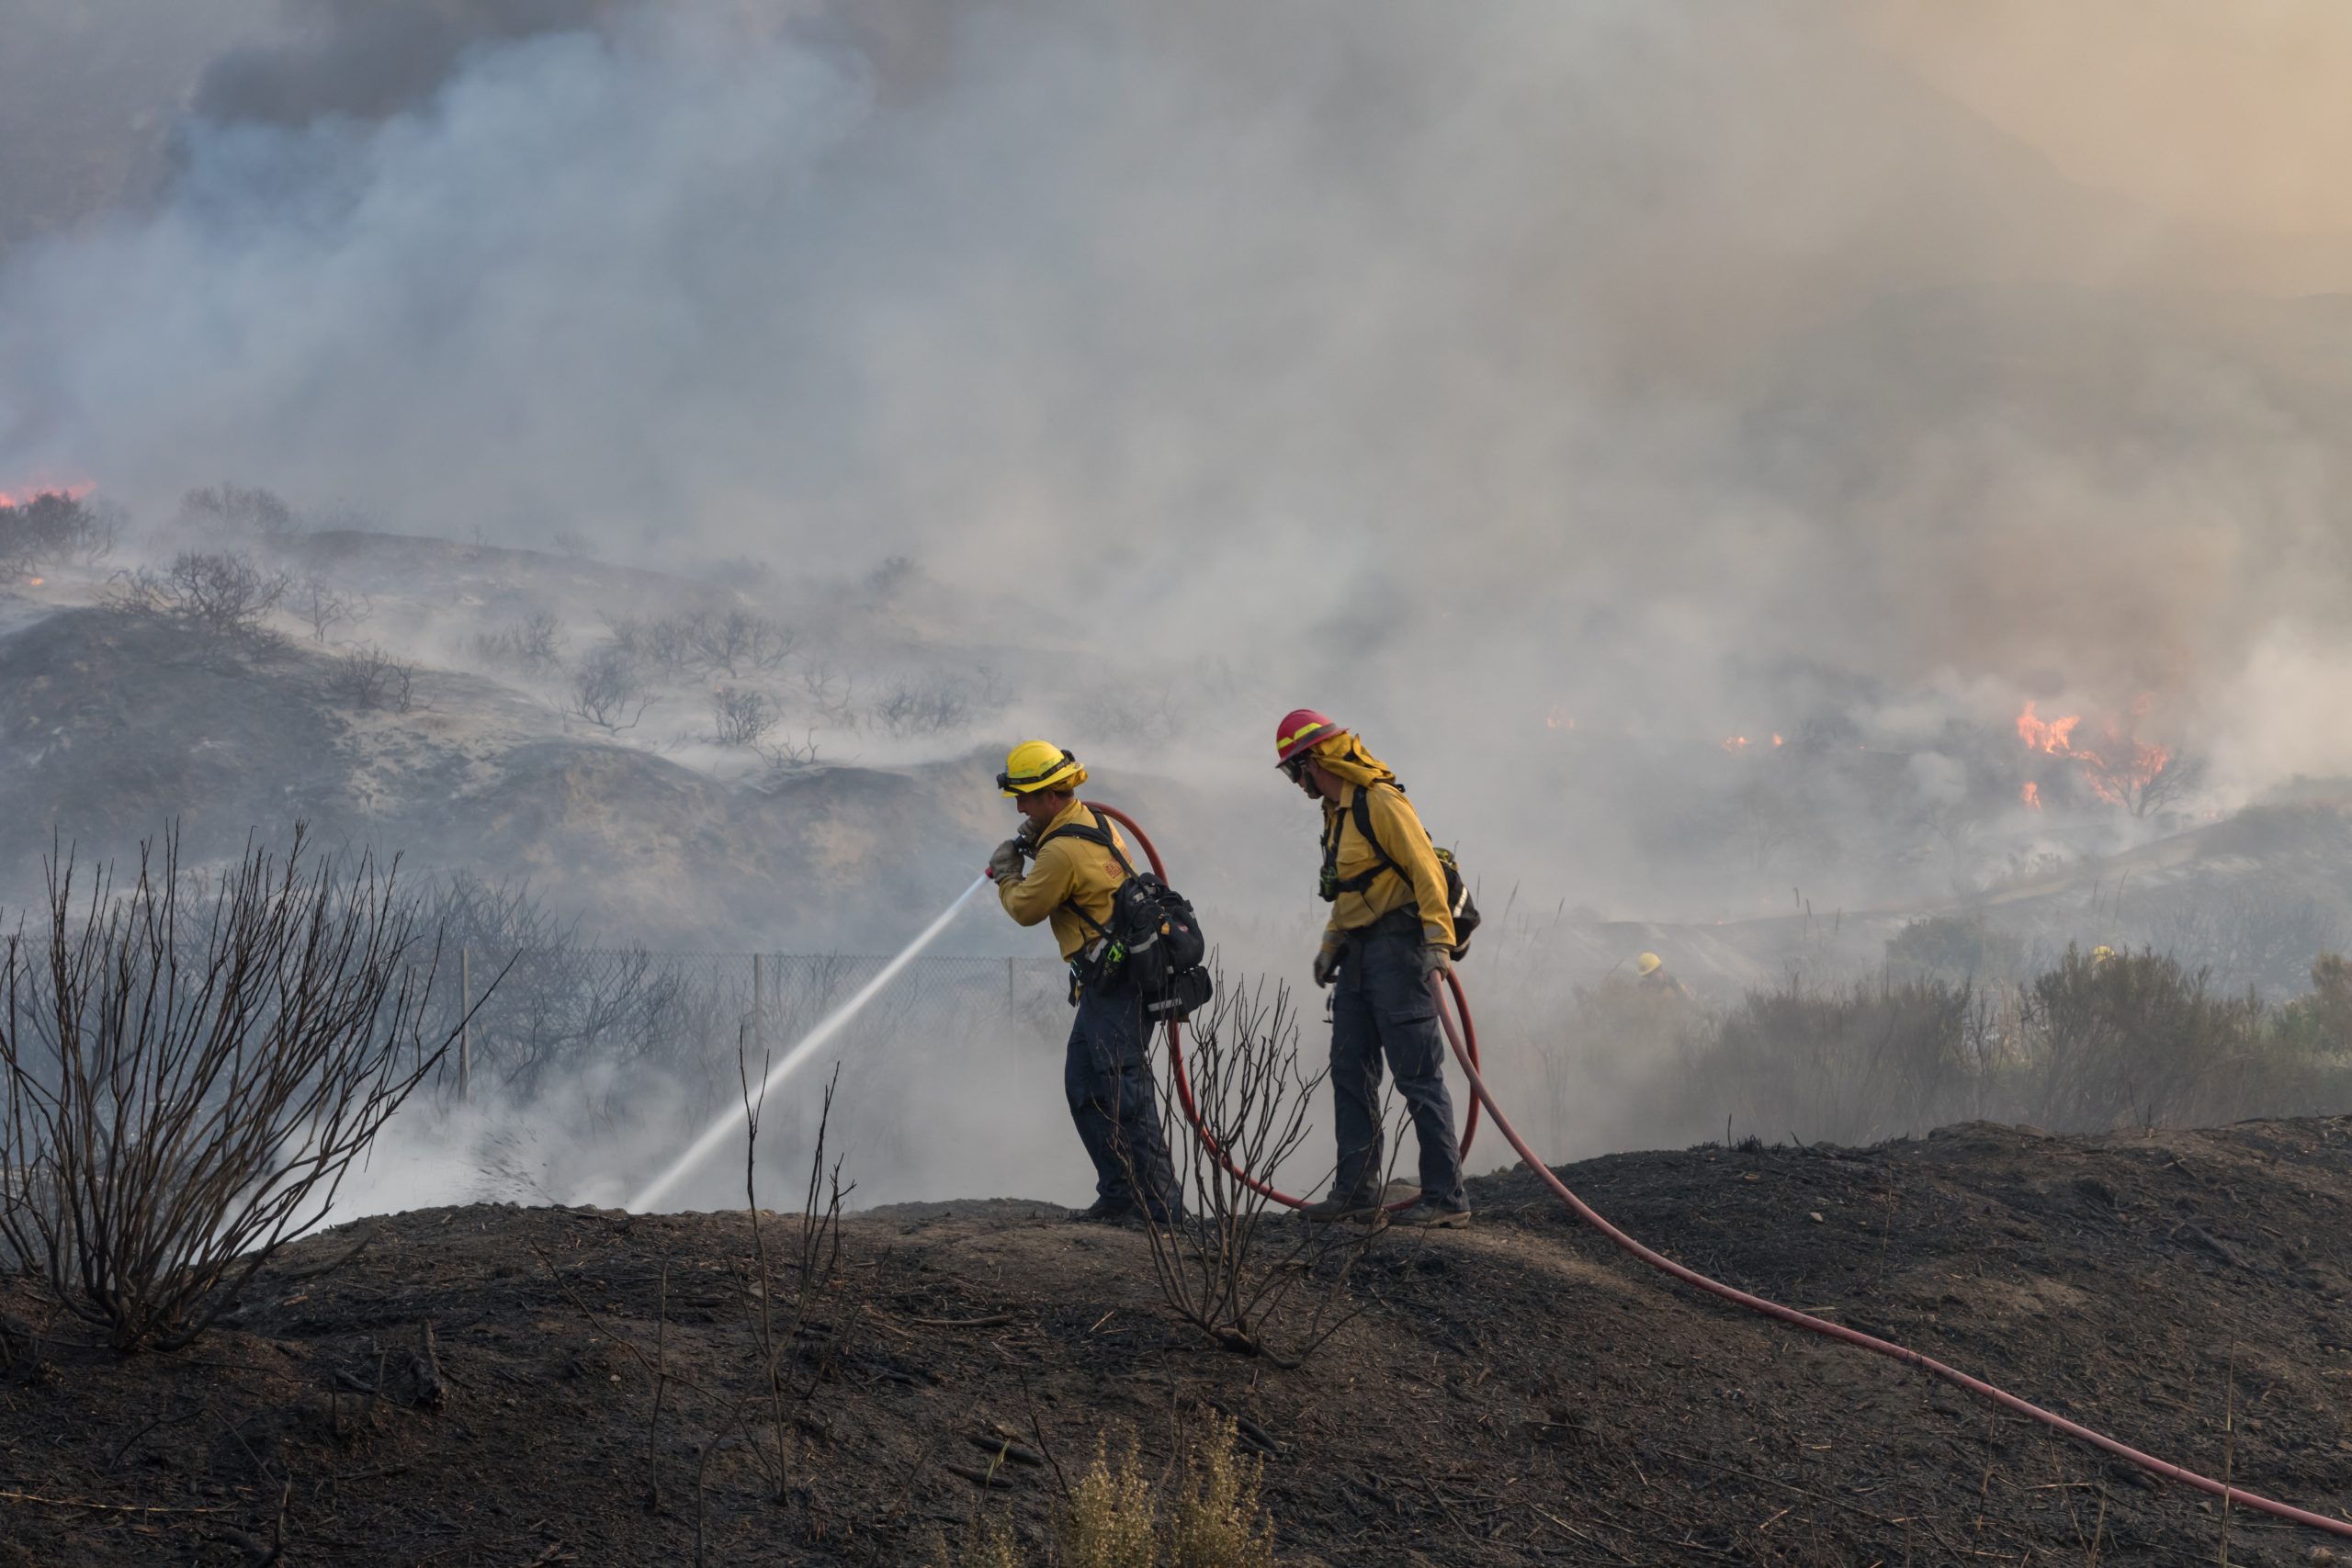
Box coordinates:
[1331,924,1470,1208]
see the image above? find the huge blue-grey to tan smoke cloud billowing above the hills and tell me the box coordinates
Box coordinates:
[14,0,2352,1213]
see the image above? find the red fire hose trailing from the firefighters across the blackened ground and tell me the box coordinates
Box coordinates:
[1087,802,2352,1540]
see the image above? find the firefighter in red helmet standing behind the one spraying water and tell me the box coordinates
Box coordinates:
[1275,707,1470,1224]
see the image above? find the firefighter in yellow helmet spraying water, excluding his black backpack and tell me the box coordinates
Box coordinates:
[988,740,1181,1223]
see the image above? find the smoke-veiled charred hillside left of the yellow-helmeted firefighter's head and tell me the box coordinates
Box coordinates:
[0,609,1021,947]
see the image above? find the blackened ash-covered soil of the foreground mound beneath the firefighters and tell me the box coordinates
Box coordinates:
[0,1119,2352,1568]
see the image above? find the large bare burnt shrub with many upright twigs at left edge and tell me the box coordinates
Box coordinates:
[0,828,457,1352]
